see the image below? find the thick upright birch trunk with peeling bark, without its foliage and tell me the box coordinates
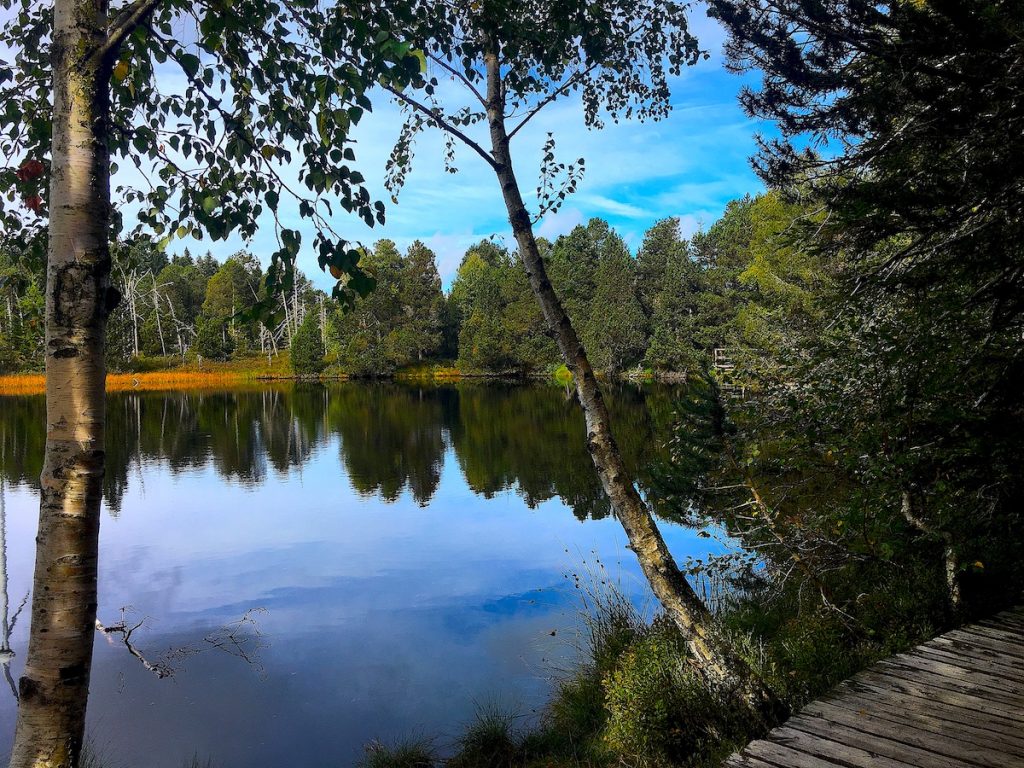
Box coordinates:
[10,0,117,768]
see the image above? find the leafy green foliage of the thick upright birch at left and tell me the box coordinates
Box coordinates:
[0,0,420,313]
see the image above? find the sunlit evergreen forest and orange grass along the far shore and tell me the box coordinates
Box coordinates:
[0,193,821,385]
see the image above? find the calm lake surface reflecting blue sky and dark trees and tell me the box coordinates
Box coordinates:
[0,383,723,768]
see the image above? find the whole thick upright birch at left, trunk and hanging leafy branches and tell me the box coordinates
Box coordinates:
[0,0,419,768]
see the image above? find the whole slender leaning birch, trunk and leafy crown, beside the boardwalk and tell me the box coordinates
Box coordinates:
[376,0,783,724]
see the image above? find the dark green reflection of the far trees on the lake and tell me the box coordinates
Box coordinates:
[0,383,688,520]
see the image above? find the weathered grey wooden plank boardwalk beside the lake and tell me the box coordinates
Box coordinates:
[724,608,1024,768]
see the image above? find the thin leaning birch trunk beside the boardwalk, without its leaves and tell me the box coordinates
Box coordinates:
[485,53,784,726]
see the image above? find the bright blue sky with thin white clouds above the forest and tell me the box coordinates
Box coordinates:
[0,7,771,290]
